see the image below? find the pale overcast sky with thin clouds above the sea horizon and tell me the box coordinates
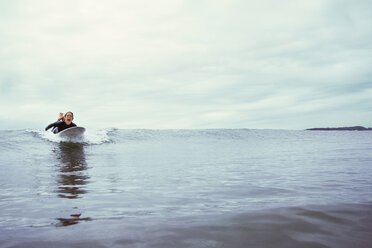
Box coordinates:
[0,0,372,129]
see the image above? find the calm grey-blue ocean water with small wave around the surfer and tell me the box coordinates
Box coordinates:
[0,129,372,248]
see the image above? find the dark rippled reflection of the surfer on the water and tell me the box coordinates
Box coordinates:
[56,142,90,226]
